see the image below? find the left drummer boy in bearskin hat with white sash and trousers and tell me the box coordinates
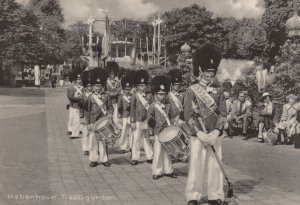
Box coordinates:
[87,68,112,167]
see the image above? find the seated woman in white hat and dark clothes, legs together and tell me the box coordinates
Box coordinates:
[257,93,275,143]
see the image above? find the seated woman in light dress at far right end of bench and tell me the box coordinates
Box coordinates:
[277,94,300,144]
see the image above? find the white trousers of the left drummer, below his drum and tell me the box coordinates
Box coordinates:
[89,132,108,163]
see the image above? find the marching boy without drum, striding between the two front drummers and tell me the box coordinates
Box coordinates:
[130,70,153,165]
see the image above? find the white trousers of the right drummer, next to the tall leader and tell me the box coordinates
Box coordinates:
[152,136,173,175]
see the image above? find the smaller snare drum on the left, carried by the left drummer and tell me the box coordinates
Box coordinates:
[93,116,121,145]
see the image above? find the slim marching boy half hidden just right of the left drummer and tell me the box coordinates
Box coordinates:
[118,72,133,154]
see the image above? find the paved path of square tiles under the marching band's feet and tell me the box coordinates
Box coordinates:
[0,89,300,205]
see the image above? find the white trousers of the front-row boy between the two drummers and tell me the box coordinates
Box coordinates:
[131,122,153,160]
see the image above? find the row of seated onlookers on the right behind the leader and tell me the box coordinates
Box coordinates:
[223,91,300,145]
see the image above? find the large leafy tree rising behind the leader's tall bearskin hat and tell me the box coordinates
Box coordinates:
[163,4,223,55]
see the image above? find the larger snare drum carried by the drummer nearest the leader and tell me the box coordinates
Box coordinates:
[158,125,190,158]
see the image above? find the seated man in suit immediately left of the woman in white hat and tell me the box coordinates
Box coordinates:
[228,91,252,140]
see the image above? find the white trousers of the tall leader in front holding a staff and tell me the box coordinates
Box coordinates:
[186,137,224,201]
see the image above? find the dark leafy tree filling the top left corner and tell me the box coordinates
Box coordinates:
[0,1,39,66]
